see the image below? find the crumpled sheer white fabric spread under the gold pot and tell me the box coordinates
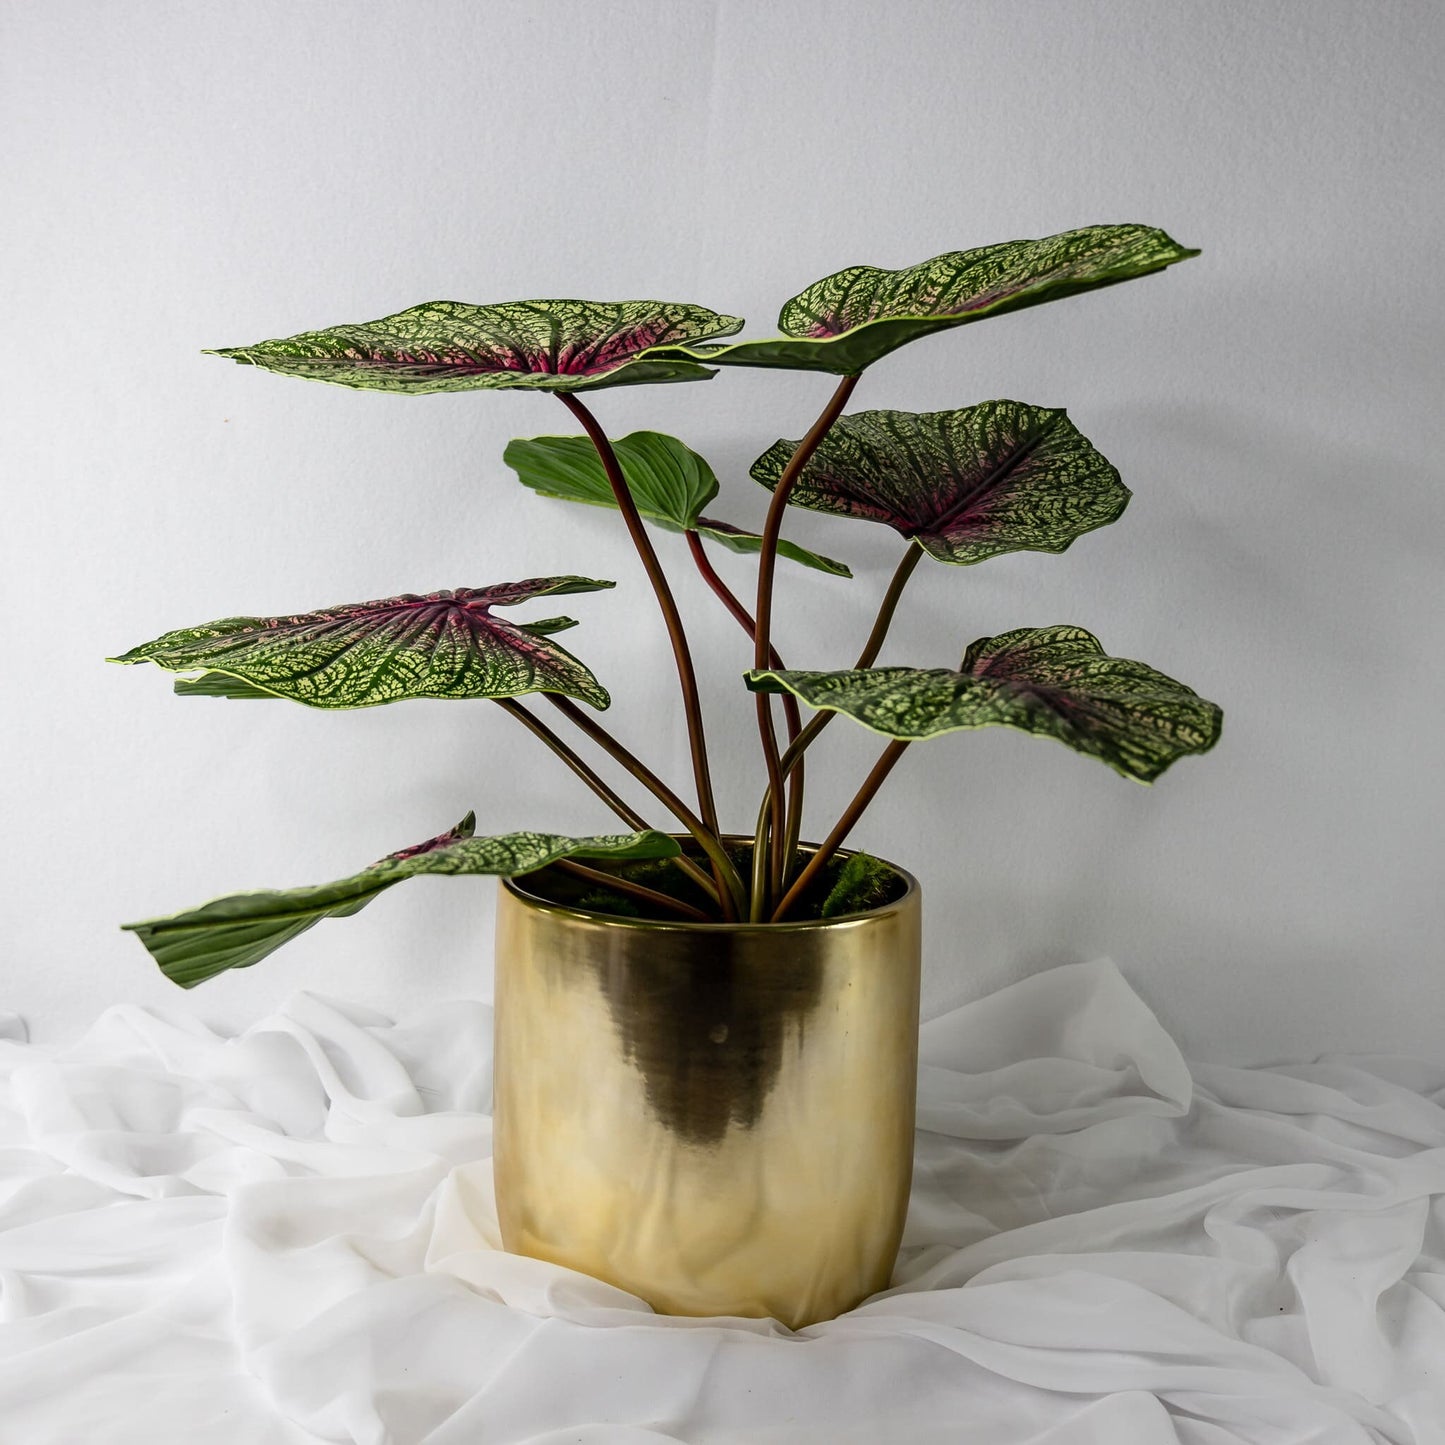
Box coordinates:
[0,962,1445,1445]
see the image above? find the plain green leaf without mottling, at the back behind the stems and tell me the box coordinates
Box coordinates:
[501,432,853,577]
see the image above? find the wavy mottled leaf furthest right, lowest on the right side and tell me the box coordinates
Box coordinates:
[747,624,1224,783]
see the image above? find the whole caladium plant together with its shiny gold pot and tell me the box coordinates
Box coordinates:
[114,225,1221,1327]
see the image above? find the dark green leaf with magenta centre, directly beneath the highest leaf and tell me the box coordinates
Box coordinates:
[751,402,1129,564]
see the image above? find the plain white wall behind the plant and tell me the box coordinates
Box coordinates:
[0,0,1445,1061]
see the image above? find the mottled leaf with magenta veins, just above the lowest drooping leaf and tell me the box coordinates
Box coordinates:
[110,577,616,708]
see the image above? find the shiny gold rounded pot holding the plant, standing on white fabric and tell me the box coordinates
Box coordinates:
[494,843,920,1329]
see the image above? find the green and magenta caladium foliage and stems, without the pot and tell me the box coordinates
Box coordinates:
[113,225,1221,987]
